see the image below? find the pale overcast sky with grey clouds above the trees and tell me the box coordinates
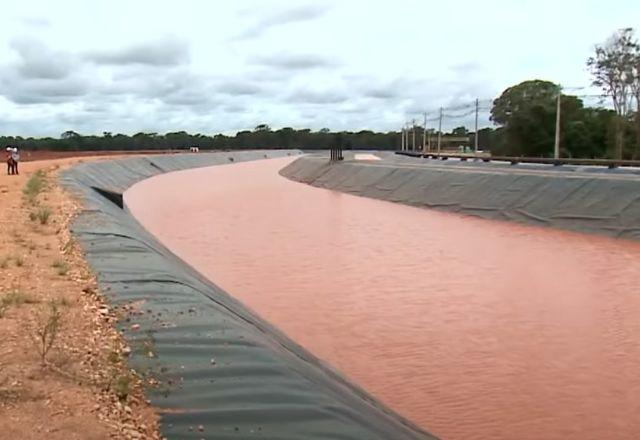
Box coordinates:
[0,0,640,137]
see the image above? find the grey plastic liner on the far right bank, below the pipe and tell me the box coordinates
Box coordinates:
[280,155,640,240]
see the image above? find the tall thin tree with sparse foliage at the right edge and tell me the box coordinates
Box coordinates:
[587,28,638,159]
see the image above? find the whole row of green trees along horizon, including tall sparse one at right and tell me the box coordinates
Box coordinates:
[0,28,640,159]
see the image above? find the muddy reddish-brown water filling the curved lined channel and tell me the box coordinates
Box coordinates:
[125,158,640,440]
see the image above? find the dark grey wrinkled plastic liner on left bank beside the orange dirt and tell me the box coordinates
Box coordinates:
[61,150,434,440]
